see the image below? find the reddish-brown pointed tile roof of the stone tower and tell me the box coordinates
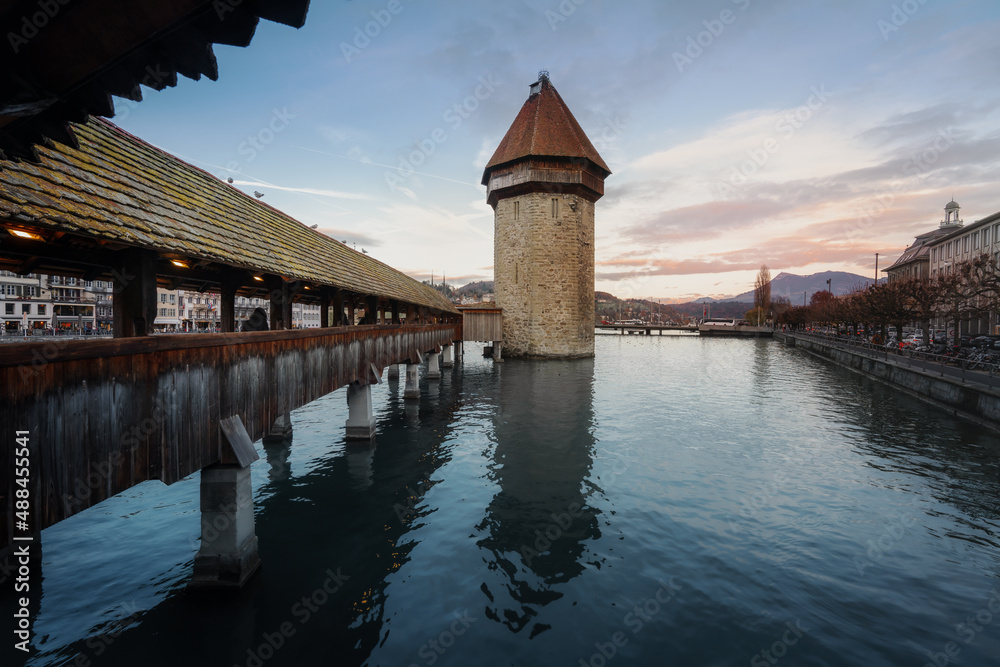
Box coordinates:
[483,76,611,185]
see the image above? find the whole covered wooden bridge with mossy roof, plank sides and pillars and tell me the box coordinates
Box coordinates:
[0,120,461,586]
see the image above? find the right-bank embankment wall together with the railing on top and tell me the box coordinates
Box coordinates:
[774,331,1000,431]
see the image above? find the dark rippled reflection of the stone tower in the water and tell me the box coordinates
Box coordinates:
[477,359,601,636]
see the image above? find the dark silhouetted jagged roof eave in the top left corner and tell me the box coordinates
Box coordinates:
[0,0,309,159]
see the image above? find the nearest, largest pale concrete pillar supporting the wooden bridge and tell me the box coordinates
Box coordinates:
[188,463,260,590]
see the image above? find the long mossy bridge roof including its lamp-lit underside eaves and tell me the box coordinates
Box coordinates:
[0,119,458,313]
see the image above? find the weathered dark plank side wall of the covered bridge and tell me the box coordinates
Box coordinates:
[0,324,462,553]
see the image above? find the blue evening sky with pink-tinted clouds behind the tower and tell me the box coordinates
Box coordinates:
[113,0,1000,301]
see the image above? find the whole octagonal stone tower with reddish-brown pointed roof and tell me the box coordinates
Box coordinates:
[483,72,611,358]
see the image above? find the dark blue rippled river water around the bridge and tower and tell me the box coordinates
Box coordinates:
[4,335,1000,667]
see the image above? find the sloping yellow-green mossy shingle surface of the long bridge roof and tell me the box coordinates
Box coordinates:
[0,120,457,312]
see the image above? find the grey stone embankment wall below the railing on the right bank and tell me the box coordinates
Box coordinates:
[774,332,1000,430]
